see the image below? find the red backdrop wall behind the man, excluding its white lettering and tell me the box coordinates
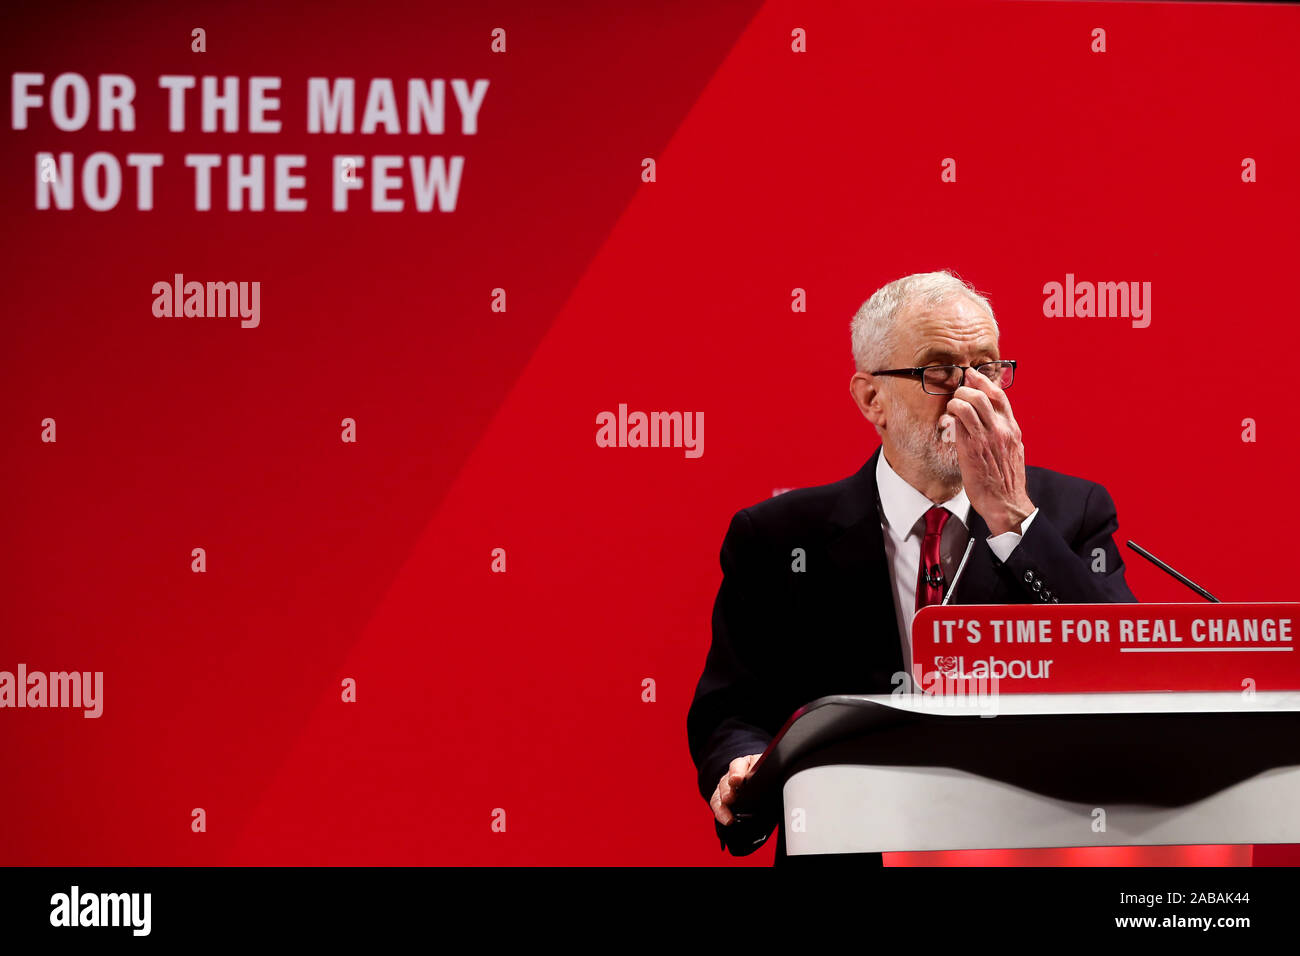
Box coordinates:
[0,1,1300,865]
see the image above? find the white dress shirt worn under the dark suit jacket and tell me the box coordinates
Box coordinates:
[876,449,1039,671]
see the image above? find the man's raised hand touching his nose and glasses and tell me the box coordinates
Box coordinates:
[948,368,1034,535]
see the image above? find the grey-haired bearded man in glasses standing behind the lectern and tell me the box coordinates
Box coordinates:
[686,272,1136,865]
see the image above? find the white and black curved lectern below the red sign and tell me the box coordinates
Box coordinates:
[737,692,1300,856]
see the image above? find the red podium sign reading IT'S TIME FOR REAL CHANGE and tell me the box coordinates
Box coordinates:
[907,604,1300,696]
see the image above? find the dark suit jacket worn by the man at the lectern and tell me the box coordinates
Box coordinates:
[686,449,1138,858]
